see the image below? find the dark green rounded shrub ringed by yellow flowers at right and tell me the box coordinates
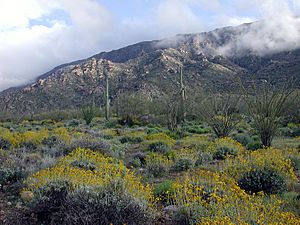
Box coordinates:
[238,168,286,194]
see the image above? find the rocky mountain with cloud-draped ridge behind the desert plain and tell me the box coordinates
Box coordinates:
[0,24,300,114]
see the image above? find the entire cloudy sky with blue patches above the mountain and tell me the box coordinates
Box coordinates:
[0,0,300,91]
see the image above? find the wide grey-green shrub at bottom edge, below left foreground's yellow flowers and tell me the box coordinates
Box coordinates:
[60,188,153,225]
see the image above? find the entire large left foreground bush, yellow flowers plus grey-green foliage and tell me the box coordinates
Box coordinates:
[23,149,154,224]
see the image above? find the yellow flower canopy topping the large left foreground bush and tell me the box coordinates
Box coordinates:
[24,148,154,203]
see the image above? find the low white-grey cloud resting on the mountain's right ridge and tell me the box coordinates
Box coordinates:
[219,0,300,56]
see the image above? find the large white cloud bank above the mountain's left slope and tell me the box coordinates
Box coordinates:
[0,0,113,90]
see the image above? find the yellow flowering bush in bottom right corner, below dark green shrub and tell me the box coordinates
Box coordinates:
[171,170,300,225]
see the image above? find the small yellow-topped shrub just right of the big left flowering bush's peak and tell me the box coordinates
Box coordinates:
[146,153,172,177]
